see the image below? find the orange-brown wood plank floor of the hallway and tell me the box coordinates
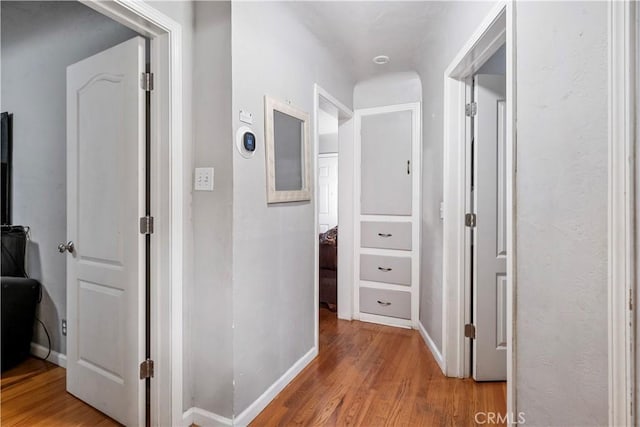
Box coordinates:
[251,309,506,427]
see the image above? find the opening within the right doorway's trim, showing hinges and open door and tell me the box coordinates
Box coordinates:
[465,45,507,381]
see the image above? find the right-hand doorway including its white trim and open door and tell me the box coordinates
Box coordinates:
[443,0,516,420]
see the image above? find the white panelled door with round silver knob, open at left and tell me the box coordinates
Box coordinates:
[66,37,145,425]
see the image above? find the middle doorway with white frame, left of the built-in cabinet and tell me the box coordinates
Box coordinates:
[314,84,353,349]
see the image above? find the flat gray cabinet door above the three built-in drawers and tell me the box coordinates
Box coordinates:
[360,111,413,216]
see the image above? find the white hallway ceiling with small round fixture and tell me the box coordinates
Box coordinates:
[288,1,448,80]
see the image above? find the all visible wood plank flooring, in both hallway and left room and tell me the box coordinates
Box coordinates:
[0,309,506,427]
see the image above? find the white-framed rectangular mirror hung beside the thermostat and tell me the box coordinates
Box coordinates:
[264,96,311,203]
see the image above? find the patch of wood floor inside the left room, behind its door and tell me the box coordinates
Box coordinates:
[0,358,120,427]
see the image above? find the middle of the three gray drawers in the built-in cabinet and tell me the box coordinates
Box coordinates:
[360,255,411,286]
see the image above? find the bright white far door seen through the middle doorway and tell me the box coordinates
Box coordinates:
[318,154,338,233]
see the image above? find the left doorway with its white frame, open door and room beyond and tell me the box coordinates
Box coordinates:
[2,2,184,425]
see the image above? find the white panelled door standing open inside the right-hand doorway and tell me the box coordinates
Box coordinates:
[473,74,507,381]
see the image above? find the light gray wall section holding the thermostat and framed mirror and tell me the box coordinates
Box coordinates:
[231,2,353,415]
